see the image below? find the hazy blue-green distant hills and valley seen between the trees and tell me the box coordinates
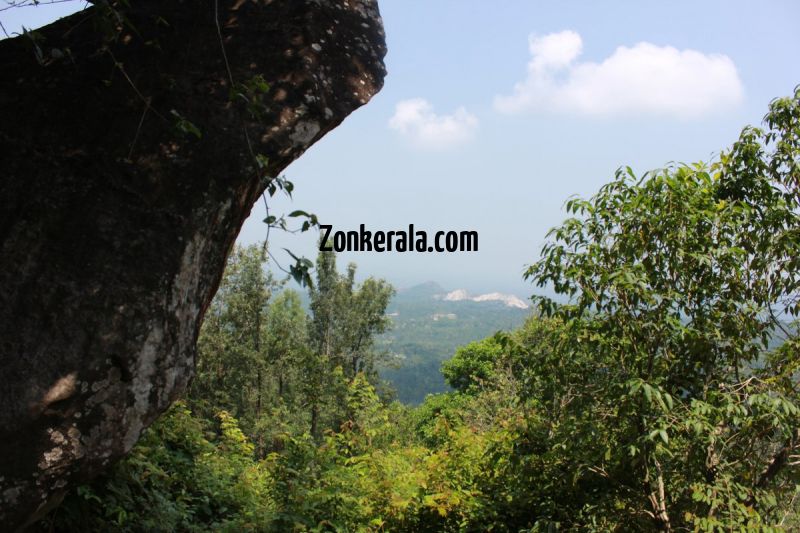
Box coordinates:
[380,282,530,404]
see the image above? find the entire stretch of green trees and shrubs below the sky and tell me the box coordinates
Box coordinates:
[34,88,800,532]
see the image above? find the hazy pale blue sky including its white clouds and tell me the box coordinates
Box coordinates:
[0,0,800,297]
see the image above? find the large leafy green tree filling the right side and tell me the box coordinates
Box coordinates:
[526,88,800,531]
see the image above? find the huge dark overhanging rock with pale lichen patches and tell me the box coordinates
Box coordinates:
[0,0,385,531]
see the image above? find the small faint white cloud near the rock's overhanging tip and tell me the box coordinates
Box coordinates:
[389,98,478,149]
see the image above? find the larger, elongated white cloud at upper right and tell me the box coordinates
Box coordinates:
[494,31,744,118]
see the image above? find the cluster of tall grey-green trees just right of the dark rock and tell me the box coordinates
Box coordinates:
[187,246,394,448]
